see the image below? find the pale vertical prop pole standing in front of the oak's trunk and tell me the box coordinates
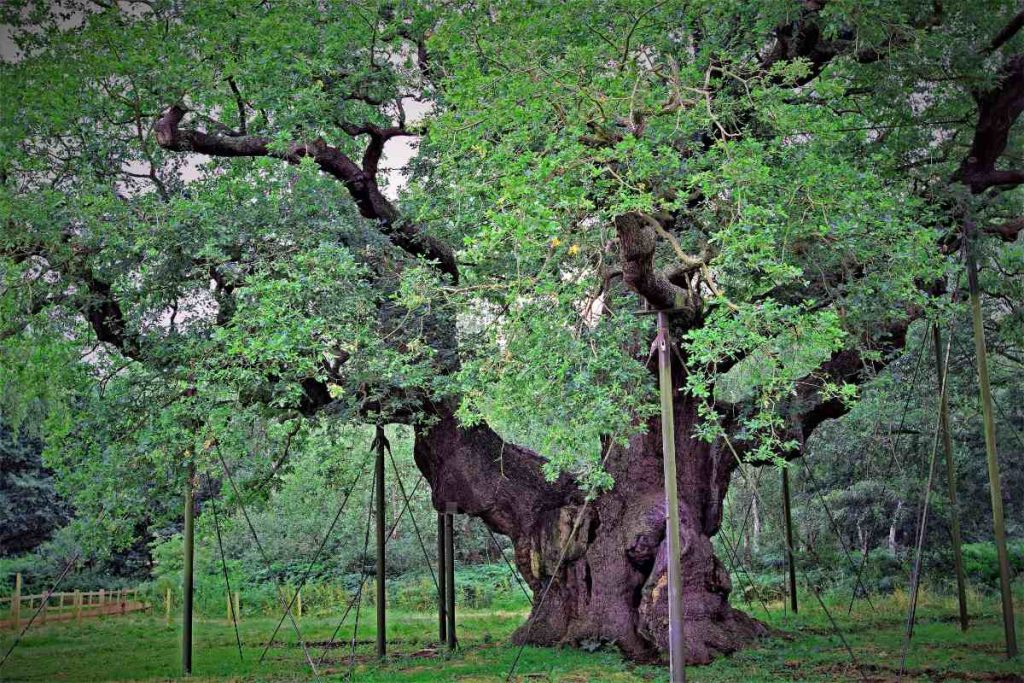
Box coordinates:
[657,312,686,683]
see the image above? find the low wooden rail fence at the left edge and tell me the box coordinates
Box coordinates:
[0,574,150,630]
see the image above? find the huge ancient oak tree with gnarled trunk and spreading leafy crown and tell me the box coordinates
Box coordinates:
[0,0,1024,663]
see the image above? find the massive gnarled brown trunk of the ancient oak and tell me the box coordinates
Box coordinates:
[416,398,765,664]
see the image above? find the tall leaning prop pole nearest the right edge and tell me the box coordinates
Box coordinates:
[967,233,1017,657]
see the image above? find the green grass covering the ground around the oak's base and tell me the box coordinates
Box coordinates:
[0,594,1024,683]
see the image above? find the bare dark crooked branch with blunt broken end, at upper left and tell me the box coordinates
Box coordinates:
[154,104,459,282]
